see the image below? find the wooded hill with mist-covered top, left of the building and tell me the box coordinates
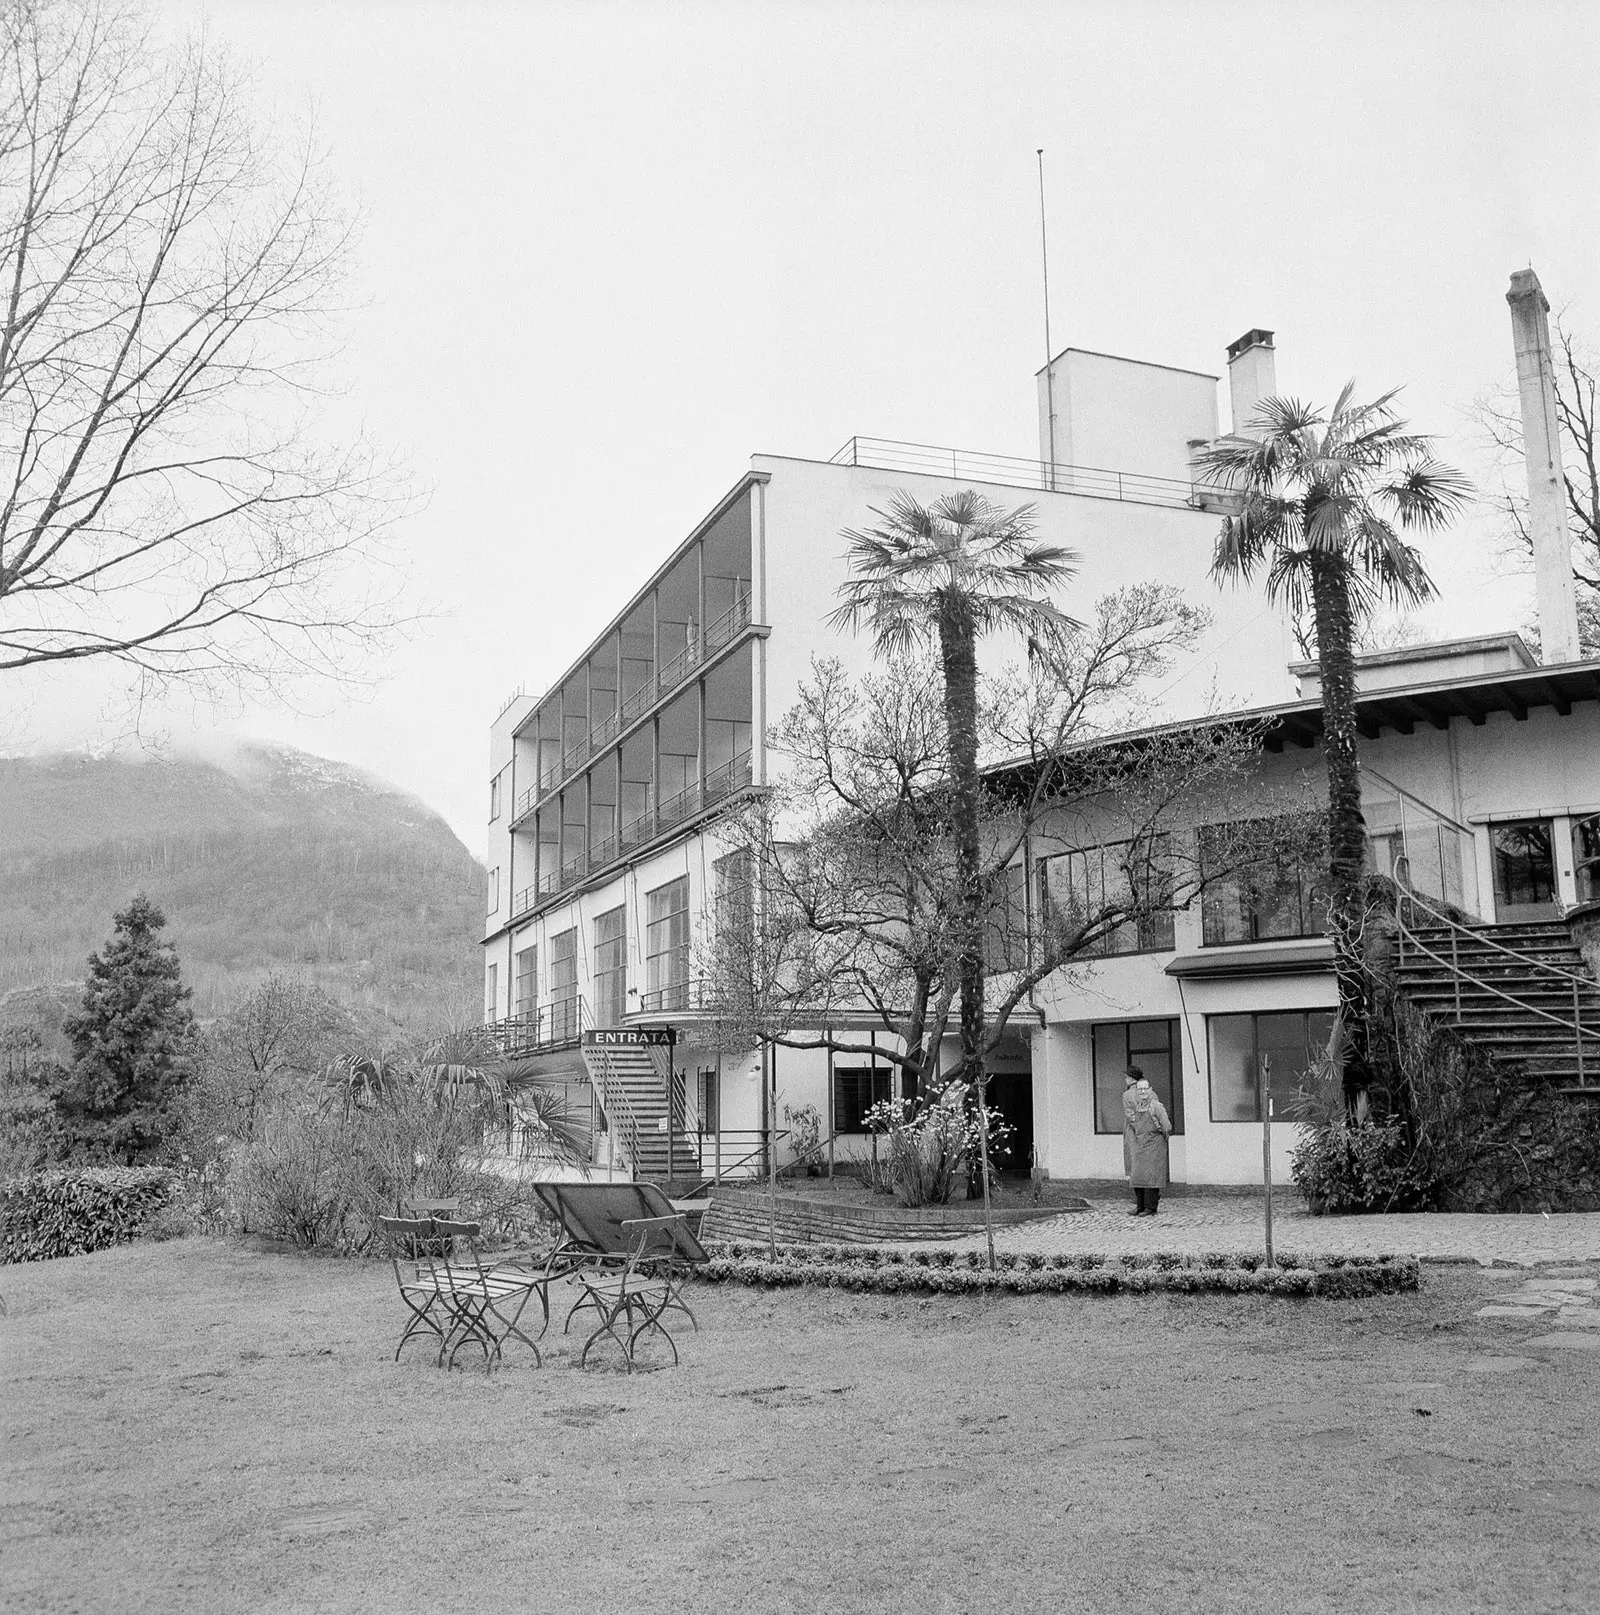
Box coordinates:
[0,743,483,1029]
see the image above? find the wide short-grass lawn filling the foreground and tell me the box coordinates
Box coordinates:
[0,1240,1600,1615]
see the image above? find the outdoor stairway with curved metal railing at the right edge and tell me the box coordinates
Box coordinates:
[1400,921,1600,1098]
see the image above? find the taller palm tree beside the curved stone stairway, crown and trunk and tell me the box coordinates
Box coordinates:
[1198,383,1471,1105]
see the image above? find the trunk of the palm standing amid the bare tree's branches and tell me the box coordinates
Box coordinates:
[940,591,988,1219]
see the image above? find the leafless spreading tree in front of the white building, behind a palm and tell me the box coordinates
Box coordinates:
[699,585,1321,1253]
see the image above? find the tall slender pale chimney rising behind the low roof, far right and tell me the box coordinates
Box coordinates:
[1506,270,1579,662]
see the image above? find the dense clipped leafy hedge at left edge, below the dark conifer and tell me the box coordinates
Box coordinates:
[0,1166,179,1263]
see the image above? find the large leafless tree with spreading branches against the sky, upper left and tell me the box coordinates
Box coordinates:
[0,0,408,707]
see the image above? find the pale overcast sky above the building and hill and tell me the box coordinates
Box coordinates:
[10,0,1600,856]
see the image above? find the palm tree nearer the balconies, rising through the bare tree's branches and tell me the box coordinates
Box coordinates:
[831,489,1077,1198]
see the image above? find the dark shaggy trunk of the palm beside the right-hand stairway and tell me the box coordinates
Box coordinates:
[1311,554,1372,1108]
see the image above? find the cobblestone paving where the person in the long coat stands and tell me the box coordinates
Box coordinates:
[951,1195,1600,1266]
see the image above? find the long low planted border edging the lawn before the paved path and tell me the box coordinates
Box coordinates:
[701,1240,1421,1297]
